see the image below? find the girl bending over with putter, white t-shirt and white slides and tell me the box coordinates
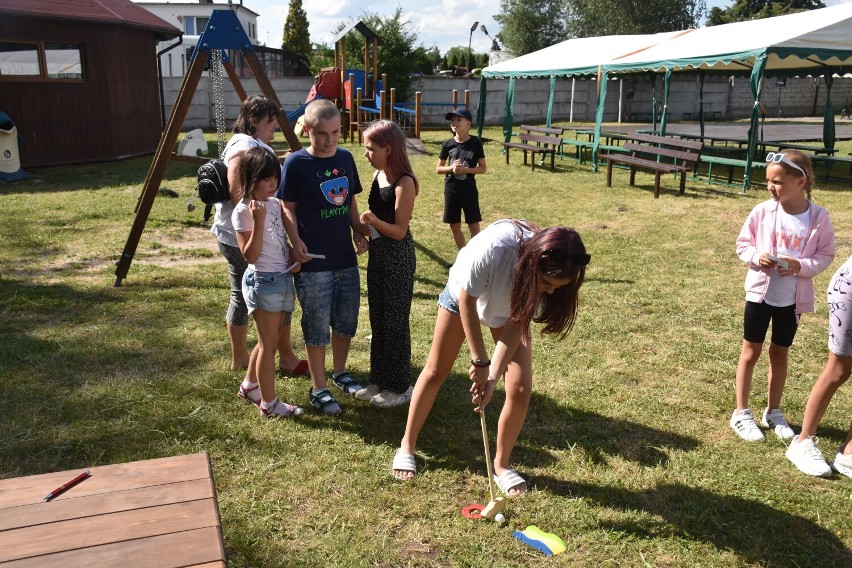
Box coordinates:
[392,220,591,497]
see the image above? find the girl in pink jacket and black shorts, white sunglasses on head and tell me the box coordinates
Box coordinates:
[730,150,834,442]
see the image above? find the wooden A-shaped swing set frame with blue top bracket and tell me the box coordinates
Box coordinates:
[114,10,302,287]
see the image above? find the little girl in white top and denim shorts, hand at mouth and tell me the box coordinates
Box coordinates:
[231,148,302,418]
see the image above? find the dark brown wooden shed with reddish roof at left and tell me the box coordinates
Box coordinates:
[0,0,181,167]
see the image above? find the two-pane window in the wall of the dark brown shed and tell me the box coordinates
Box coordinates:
[0,41,86,81]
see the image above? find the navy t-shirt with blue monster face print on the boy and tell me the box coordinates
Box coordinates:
[275,148,362,272]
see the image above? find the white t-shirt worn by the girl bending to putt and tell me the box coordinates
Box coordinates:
[447,220,532,327]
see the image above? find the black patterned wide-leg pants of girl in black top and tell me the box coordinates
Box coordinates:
[367,232,417,393]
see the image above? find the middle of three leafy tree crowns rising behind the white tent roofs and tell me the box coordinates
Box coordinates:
[565,0,707,37]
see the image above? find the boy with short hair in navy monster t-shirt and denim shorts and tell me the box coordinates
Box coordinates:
[275,100,367,414]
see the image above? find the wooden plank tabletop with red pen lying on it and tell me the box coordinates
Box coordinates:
[0,453,226,568]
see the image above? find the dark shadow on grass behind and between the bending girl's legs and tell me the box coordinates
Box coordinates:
[300,367,699,471]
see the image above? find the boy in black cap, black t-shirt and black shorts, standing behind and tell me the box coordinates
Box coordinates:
[435,106,485,249]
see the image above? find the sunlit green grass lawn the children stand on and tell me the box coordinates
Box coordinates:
[0,123,852,567]
